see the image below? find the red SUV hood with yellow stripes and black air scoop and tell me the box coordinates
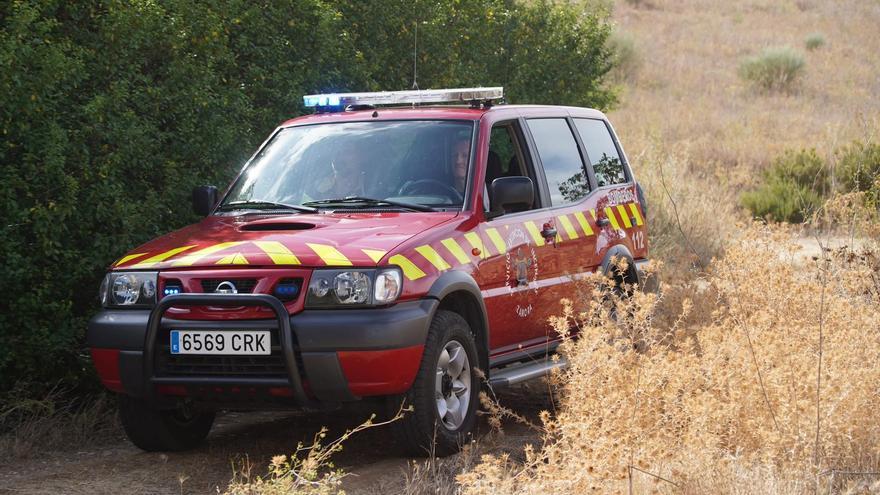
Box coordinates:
[112,212,457,270]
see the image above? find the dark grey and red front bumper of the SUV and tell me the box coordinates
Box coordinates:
[87,294,438,405]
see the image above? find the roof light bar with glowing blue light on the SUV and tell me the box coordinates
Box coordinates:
[303,87,504,107]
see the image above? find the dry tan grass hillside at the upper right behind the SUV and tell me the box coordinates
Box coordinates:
[610,0,880,191]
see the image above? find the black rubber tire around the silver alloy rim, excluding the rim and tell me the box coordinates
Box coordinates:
[389,310,481,457]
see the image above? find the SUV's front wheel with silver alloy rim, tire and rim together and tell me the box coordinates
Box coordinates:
[394,310,480,456]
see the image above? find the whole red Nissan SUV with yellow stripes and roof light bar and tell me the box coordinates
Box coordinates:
[88,88,647,454]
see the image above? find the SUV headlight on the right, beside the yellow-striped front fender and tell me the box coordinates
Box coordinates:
[306,268,401,308]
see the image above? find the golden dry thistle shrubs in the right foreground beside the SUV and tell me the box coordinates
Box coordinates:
[459,225,880,494]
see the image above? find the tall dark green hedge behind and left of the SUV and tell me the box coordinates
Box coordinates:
[0,0,615,397]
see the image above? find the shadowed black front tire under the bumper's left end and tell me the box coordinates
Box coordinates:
[119,395,214,452]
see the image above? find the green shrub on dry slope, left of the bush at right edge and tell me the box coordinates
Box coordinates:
[741,150,831,223]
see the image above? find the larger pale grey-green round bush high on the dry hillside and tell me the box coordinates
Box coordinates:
[739,47,806,91]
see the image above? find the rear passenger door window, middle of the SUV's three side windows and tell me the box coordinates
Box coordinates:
[528,119,590,206]
